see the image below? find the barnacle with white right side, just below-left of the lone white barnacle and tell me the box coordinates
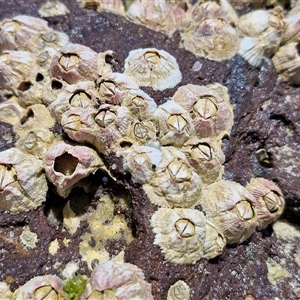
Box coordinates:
[97,73,139,105]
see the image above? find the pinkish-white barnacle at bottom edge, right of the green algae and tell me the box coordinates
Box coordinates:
[80,261,154,300]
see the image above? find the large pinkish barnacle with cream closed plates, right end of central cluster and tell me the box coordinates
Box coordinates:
[172,84,233,140]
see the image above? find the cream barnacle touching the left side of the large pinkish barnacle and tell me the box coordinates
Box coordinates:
[153,100,195,147]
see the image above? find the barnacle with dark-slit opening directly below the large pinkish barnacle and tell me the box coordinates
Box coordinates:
[181,138,225,184]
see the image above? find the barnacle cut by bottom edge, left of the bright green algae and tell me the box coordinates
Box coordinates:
[12,275,67,300]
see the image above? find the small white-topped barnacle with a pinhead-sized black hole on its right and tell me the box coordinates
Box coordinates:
[123,146,162,184]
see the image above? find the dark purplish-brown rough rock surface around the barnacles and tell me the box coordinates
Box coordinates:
[0,0,300,300]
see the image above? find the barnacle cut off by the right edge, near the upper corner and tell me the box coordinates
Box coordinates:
[272,43,300,85]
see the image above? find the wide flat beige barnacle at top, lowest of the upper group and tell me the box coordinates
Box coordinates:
[184,18,239,61]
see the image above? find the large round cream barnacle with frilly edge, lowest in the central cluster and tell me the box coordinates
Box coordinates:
[151,208,206,264]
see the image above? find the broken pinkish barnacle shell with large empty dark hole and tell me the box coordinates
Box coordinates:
[44,141,103,198]
